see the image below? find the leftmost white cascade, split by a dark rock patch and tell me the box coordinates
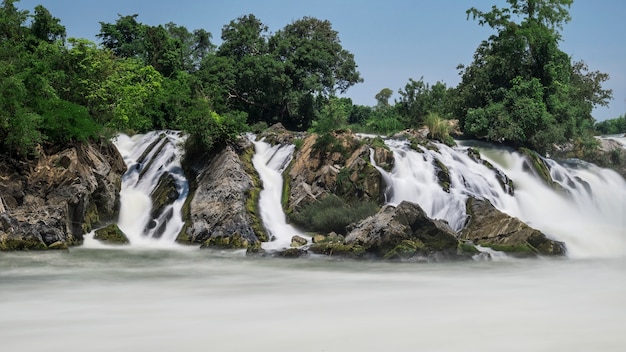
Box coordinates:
[114,131,189,245]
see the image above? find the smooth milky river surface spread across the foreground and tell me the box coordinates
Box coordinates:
[0,247,626,352]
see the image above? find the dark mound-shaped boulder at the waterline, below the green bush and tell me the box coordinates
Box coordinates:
[345,202,466,260]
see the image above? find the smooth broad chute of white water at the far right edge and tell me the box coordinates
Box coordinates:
[481,148,626,257]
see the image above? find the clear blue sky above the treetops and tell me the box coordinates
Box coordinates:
[17,0,626,120]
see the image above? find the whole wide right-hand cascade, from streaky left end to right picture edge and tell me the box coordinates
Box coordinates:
[372,140,626,257]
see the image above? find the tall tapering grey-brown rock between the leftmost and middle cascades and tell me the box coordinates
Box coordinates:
[183,139,260,248]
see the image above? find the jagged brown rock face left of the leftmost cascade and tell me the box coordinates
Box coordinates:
[0,143,126,250]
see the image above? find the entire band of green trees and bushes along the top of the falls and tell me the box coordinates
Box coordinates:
[0,0,626,158]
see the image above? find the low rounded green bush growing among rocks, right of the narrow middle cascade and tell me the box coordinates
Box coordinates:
[290,194,378,234]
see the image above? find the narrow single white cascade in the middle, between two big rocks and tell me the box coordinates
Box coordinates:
[249,135,307,250]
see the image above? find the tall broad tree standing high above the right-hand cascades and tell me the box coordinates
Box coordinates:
[455,0,611,152]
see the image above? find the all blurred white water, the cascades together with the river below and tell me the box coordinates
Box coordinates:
[0,134,626,351]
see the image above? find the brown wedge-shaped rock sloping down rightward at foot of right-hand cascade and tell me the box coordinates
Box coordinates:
[461,198,566,257]
